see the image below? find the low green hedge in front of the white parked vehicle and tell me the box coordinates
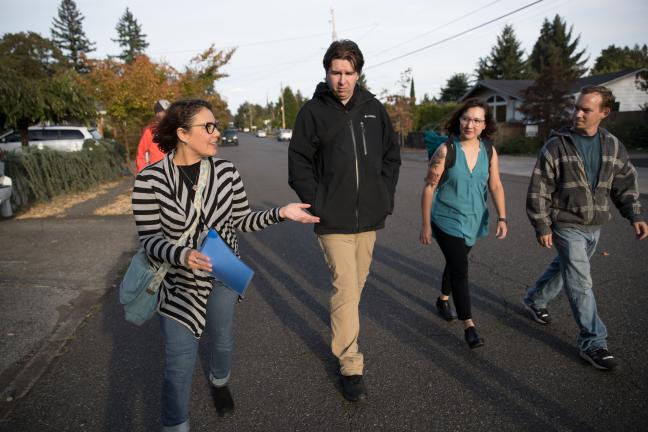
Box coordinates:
[5,139,124,211]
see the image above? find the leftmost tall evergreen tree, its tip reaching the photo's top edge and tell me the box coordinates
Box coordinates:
[50,0,95,72]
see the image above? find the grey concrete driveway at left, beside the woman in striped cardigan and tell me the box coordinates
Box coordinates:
[0,177,137,412]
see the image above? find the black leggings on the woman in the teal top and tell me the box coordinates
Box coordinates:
[432,223,472,321]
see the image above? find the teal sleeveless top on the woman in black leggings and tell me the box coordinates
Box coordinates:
[432,141,488,246]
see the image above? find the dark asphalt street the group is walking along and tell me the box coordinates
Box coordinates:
[0,134,648,432]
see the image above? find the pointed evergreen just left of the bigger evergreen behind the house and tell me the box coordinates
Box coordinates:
[475,25,528,80]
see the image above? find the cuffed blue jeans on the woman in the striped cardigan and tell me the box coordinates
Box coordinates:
[160,282,238,432]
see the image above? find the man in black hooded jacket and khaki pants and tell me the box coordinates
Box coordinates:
[288,40,400,401]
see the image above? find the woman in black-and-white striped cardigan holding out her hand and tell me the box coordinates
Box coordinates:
[133,100,319,431]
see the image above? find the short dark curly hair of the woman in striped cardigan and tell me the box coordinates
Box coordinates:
[153,99,213,153]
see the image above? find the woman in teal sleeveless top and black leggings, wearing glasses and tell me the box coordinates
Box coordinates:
[420,99,507,348]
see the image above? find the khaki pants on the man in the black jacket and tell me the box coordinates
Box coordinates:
[318,231,376,375]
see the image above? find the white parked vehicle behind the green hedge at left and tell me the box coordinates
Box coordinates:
[0,126,102,151]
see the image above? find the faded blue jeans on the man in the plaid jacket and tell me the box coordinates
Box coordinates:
[524,228,607,351]
